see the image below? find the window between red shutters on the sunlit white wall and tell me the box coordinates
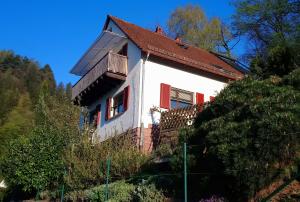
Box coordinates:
[170,88,193,109]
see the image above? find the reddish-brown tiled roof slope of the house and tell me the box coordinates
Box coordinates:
[105,16,243,80]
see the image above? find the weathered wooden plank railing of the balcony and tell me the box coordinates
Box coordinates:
[72,52,127,99]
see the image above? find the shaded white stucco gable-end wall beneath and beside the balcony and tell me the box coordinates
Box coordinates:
[88,22,142,140]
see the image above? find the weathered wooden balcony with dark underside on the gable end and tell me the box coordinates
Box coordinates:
[72,52,127,105]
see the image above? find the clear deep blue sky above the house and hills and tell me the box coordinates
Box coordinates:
[0,0,244,83]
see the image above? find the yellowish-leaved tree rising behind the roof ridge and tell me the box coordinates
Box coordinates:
[168,5,238,56]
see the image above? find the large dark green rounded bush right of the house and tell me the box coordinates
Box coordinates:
[189,70,300,200]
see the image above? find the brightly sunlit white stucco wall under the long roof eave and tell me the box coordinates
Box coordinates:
[142,61,226,127]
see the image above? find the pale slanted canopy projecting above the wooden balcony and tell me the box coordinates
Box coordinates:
[70,30,128,76]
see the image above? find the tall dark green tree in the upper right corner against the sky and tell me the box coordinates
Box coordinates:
[233,0,300,78]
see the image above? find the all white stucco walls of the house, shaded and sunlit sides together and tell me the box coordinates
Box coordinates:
[89,19,226,140]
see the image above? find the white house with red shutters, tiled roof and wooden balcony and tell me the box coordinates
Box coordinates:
[71,16,243,151]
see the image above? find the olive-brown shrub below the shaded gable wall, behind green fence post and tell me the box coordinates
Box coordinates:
[65,133,148,190]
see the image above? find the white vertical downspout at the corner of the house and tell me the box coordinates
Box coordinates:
[139,51,150,149]
